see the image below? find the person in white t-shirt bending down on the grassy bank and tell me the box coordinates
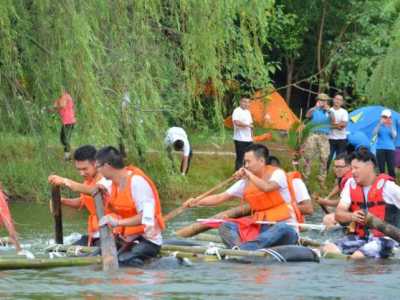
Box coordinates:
[164,127,193,175]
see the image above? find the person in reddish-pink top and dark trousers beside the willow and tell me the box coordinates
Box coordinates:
[53,89,76,160]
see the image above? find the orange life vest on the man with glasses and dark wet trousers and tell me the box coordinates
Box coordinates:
[107,166,165,237]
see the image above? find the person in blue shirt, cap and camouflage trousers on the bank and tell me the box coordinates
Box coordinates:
[303,93,331,184]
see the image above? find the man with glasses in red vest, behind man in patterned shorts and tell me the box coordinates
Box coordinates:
[317,153,352,228]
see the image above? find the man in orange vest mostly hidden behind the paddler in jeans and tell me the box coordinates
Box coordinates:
[268,155,314,223]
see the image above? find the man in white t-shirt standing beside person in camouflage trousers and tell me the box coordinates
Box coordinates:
[327,94,349,170]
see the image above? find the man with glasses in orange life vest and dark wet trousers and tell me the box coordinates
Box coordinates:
[51,146,165,267]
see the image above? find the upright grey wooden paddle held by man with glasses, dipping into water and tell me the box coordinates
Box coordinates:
[93,189,119,271]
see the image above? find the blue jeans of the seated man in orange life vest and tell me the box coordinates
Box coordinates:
[219,222,298,250]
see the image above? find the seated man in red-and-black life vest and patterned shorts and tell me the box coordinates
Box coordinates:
[323,149,400,258]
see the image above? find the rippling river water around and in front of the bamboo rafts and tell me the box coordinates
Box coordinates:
[0,202,400,299]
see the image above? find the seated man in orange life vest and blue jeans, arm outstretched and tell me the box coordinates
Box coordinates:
[184,144,298,250]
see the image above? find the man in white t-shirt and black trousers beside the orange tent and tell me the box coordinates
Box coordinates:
[232,98,253,170]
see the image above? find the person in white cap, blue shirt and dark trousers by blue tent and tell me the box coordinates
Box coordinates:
[372,109,397,178]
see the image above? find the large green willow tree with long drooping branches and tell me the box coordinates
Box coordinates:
[0,0,274,200]
